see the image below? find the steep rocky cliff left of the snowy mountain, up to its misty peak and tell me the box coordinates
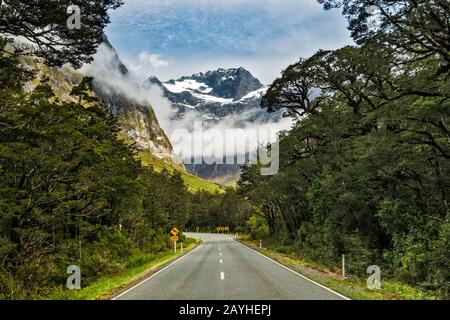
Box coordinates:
[86,39,185,170]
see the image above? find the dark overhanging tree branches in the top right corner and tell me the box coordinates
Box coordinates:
[318,0,450,74]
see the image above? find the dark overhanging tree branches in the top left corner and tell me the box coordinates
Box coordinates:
[0,0,122,67]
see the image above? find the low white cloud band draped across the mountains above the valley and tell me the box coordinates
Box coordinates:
[81,45,292,162]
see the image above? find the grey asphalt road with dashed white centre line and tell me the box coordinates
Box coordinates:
[115,233,345,300]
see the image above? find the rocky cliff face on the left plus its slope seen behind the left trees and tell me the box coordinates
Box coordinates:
[23,39,185,171]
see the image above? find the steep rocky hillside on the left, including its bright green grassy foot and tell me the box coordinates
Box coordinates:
[24,39,222,192]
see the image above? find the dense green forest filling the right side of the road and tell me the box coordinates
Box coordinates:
[234,0,450,295]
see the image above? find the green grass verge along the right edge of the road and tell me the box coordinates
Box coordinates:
[241,235,442,300]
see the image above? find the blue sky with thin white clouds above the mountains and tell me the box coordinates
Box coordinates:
[107,0,352,84]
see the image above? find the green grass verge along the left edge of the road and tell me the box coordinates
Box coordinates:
[48,239,200,300]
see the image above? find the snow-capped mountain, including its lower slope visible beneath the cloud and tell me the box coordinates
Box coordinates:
[145,68,282,184]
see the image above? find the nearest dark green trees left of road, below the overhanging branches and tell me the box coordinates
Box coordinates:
[0,80,139,298]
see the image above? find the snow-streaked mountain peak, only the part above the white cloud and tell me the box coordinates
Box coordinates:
[146,68,280,127]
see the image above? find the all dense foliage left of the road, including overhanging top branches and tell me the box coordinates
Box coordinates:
[0,1,191,299]
